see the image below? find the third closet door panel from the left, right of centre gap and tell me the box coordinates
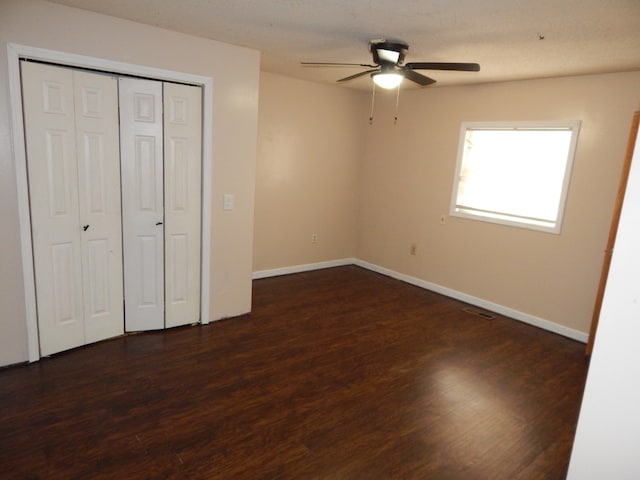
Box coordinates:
[119,78,164,331]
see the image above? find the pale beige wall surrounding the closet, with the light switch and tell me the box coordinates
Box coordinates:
[0,0,260,365]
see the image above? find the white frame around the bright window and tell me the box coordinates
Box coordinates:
[449,120,580,234]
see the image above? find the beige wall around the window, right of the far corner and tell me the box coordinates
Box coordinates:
[357,73,640,332]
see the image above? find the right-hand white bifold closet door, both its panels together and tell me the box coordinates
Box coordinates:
[119,78,202,331]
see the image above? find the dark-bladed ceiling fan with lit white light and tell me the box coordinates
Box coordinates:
[302,40,480,88]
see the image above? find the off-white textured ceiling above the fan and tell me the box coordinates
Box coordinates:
[50,0,640,89]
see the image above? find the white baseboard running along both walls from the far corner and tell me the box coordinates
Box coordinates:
[253,258,588,343]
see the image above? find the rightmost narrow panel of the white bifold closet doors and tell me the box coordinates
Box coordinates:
[164,83,202,327]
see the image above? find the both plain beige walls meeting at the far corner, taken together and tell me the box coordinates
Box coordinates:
[254,72,640,336]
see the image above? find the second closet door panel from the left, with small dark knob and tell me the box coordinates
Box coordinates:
[73,71,124,343]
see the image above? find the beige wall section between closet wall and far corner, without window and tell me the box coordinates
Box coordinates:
[253,72,368,271]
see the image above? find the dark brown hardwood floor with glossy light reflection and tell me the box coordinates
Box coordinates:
[0,266,587,480]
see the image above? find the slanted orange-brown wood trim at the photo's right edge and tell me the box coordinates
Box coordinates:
[585,112,640,355]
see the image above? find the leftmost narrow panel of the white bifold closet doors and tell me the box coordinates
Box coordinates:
[21,62,84,356]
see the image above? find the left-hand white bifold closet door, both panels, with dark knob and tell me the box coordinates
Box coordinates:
[21,61,124,355]
